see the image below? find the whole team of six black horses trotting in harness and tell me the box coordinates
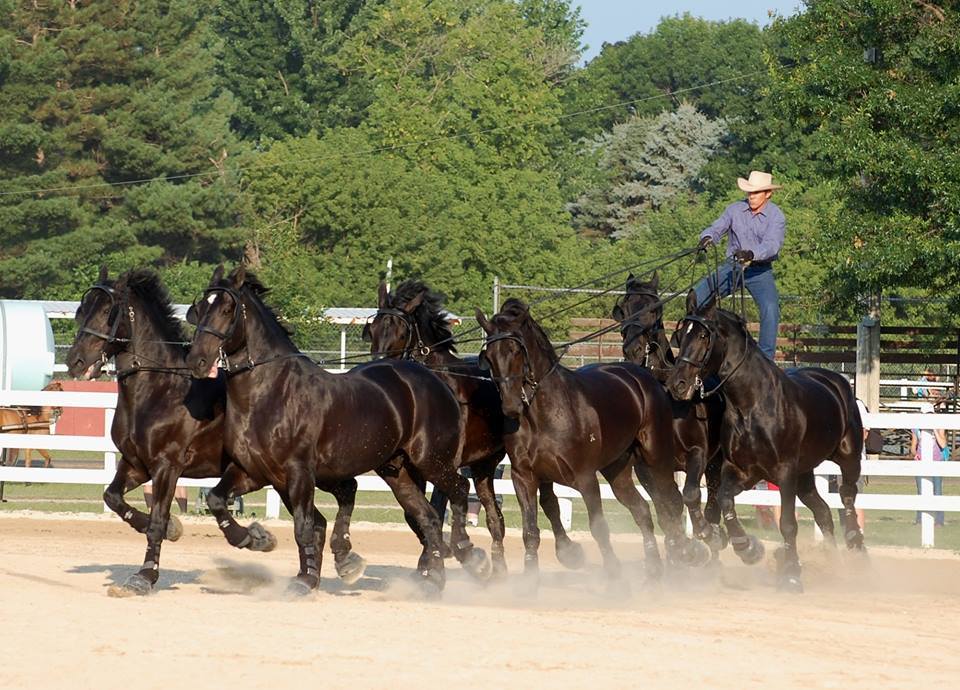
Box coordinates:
[67,266,864,596]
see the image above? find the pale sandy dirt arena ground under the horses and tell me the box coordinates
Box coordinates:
[0,513,960,690]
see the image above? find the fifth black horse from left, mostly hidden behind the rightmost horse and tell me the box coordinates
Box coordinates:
[612,273,725,556]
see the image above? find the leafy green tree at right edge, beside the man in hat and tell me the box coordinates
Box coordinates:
[773,0,960,308]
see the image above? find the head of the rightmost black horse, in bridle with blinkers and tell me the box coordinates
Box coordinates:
[667,290,727,400]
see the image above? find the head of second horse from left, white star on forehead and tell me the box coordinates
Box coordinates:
[187,265,247,378]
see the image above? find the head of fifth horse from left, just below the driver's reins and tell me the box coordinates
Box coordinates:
[611,273,669,366]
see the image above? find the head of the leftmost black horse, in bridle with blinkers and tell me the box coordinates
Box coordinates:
[67,266,129,380]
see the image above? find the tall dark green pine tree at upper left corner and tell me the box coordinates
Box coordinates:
[0,0,248,297]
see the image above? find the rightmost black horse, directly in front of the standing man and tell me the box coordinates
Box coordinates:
[668,291,864,591]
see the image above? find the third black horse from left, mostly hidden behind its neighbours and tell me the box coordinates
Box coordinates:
[363,280,584,575]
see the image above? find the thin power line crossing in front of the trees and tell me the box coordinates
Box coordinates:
[0,70,766,197]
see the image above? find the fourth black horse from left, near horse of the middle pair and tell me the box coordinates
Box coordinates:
[477,299,705,587]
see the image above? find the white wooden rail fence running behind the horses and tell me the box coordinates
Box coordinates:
[0,391,960,547]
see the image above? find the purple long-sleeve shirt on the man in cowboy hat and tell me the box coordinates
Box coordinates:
[700,200,787,261]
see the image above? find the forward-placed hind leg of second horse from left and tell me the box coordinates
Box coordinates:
[377,460,446,593]
